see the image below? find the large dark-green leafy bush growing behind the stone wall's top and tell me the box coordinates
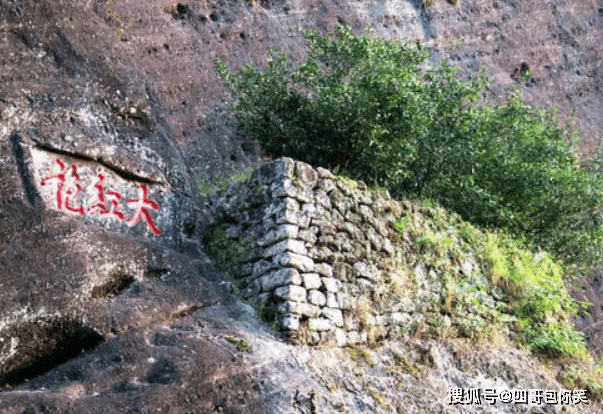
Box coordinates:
[216,25,603,265]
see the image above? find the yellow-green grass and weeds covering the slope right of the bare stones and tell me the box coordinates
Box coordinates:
[386,201,603,401]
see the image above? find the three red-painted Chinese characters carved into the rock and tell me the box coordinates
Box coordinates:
[41,158,161,236]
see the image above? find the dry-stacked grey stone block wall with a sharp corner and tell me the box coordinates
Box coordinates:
[198,158,444,346]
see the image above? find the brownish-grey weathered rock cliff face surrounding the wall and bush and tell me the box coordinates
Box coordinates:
[0,0,603,413]
